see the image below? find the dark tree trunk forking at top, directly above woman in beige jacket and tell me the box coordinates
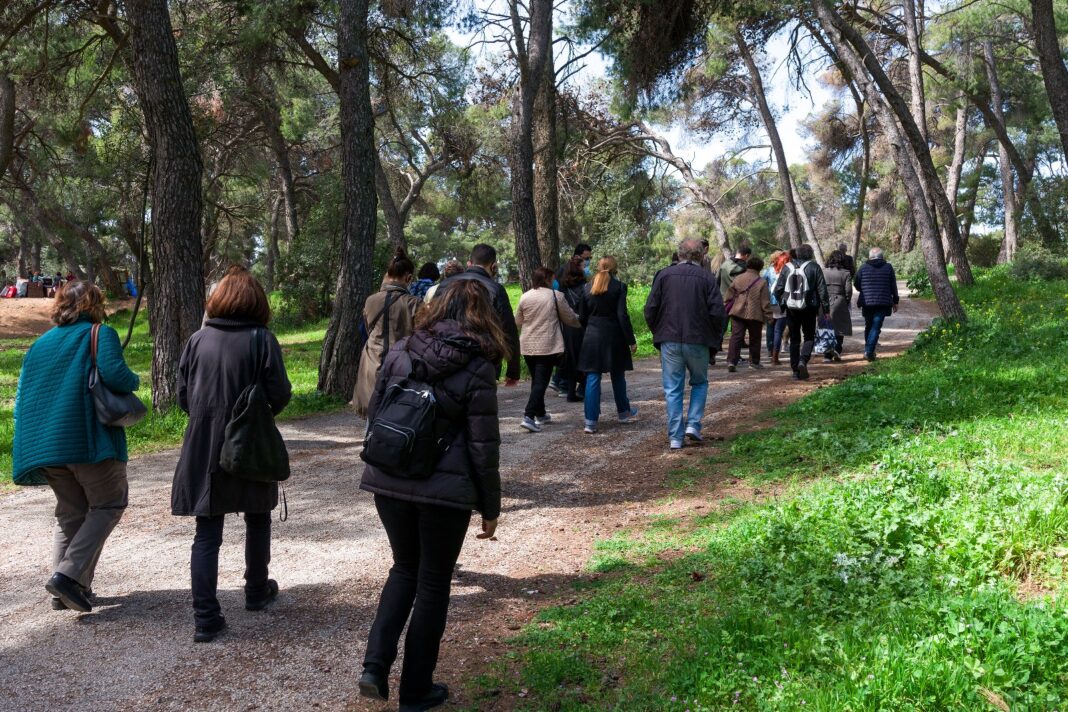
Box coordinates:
[508,0,553,289]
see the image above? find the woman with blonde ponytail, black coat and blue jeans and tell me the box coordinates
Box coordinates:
[579,256,638,434]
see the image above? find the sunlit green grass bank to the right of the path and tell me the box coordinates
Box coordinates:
[476,270,1068,711]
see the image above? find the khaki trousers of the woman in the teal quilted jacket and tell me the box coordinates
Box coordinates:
[45,460,129,588]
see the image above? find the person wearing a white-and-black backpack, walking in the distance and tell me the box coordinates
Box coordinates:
[774,244,831,380]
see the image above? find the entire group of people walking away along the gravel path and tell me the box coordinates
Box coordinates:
[13,240,897,710]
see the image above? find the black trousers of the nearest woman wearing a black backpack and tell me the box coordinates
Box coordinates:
[363,494,471,705]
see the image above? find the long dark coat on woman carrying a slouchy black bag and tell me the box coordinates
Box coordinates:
[171,319,292,517]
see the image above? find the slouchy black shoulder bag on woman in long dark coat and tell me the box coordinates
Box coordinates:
[219,329,289,482]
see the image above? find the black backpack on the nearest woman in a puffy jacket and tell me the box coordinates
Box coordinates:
[360,351,462,479]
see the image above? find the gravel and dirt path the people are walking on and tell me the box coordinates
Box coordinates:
[0,290,933,711]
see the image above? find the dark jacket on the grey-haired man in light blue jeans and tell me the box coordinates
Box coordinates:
[645,262,725,348]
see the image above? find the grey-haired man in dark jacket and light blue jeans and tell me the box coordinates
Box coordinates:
[644,239,725,449]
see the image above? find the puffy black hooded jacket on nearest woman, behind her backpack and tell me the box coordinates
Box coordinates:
[360,320,501,519]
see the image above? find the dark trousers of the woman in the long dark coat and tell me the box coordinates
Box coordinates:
[189,512,270,626]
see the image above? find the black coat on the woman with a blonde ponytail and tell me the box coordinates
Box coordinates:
[579,278,635,374]
